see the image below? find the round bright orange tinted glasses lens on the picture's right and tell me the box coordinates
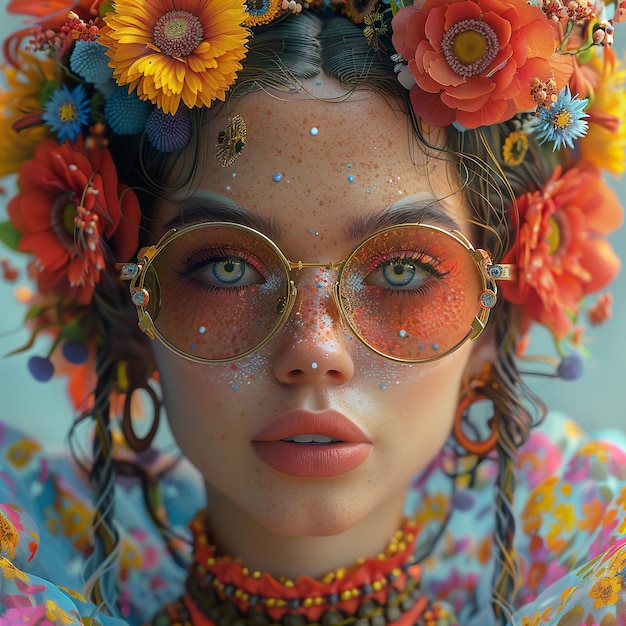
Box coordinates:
[339,225,484,361]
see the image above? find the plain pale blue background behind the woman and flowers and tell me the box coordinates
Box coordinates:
[0,0,626,446]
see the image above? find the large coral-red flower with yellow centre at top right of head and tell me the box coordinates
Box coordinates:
[392,0,572,128]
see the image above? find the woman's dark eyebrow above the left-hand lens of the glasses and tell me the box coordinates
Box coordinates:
[165,194,280,239]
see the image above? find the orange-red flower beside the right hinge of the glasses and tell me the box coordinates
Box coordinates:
[501,164,623,339]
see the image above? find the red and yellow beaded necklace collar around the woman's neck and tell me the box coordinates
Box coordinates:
[151,512,457,626]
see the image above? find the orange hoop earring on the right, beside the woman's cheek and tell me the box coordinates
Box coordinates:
[452,364,499,458]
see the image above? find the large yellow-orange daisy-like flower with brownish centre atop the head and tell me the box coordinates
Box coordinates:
[99,0,249,114]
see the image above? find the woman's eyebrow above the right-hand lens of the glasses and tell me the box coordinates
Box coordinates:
[349,198,460,241]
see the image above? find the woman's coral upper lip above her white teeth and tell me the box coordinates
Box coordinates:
[252,410,370,443]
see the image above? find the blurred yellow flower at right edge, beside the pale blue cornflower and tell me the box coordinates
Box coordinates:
[580,55,626,176]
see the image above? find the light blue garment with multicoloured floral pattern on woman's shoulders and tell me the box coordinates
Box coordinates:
[0,414,626,626]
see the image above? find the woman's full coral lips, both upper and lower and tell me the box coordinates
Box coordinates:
[252,411,372,478]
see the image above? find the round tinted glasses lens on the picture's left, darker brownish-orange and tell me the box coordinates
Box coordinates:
[144,224,289,361]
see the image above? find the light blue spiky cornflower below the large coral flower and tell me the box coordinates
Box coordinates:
[535,87,589,150]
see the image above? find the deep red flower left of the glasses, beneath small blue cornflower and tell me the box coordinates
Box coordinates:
[8,140,140,304]
